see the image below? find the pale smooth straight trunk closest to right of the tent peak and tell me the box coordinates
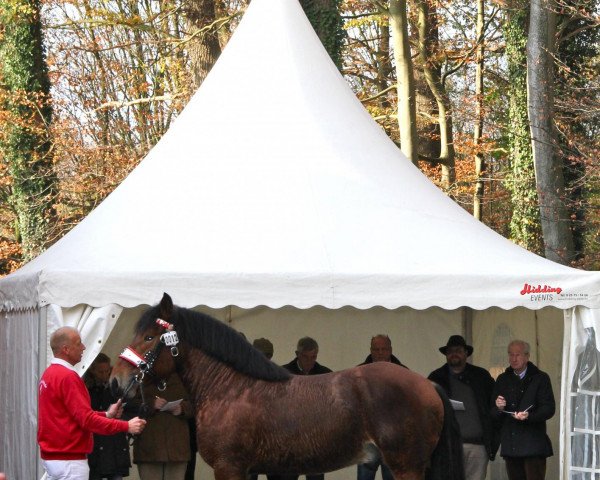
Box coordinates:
[390,0,418,165]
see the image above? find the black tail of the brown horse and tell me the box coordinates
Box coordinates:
[425,383,465,480]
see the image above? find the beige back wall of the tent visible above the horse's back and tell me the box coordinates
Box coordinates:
[225,307,463,375]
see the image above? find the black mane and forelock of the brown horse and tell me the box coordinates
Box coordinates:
[135,305,291,381]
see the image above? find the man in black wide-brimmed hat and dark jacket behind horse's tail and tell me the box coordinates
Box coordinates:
[428,335,498,480]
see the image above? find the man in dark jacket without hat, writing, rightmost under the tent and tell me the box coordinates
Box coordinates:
[492,340,556,480]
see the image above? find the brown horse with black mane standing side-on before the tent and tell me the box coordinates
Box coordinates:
[111,294,464,480]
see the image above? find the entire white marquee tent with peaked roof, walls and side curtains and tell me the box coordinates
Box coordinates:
[0,0,600,479]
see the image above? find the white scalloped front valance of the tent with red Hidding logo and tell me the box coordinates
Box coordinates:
[24,270,600,310]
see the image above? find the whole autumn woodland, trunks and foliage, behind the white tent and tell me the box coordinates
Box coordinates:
[0,0,600,275]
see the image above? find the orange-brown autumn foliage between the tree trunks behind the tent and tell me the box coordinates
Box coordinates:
[0,0,600,274]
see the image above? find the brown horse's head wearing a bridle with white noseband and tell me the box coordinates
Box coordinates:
[110,293,179,399]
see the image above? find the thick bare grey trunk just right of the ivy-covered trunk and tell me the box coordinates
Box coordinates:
[527,0,574,264]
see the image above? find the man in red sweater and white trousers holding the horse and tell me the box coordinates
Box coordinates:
[38,327,146,480]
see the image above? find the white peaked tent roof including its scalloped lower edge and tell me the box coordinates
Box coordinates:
[0,0,600,309]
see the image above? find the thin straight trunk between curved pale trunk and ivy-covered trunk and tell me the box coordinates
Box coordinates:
[473,0,485,221]
